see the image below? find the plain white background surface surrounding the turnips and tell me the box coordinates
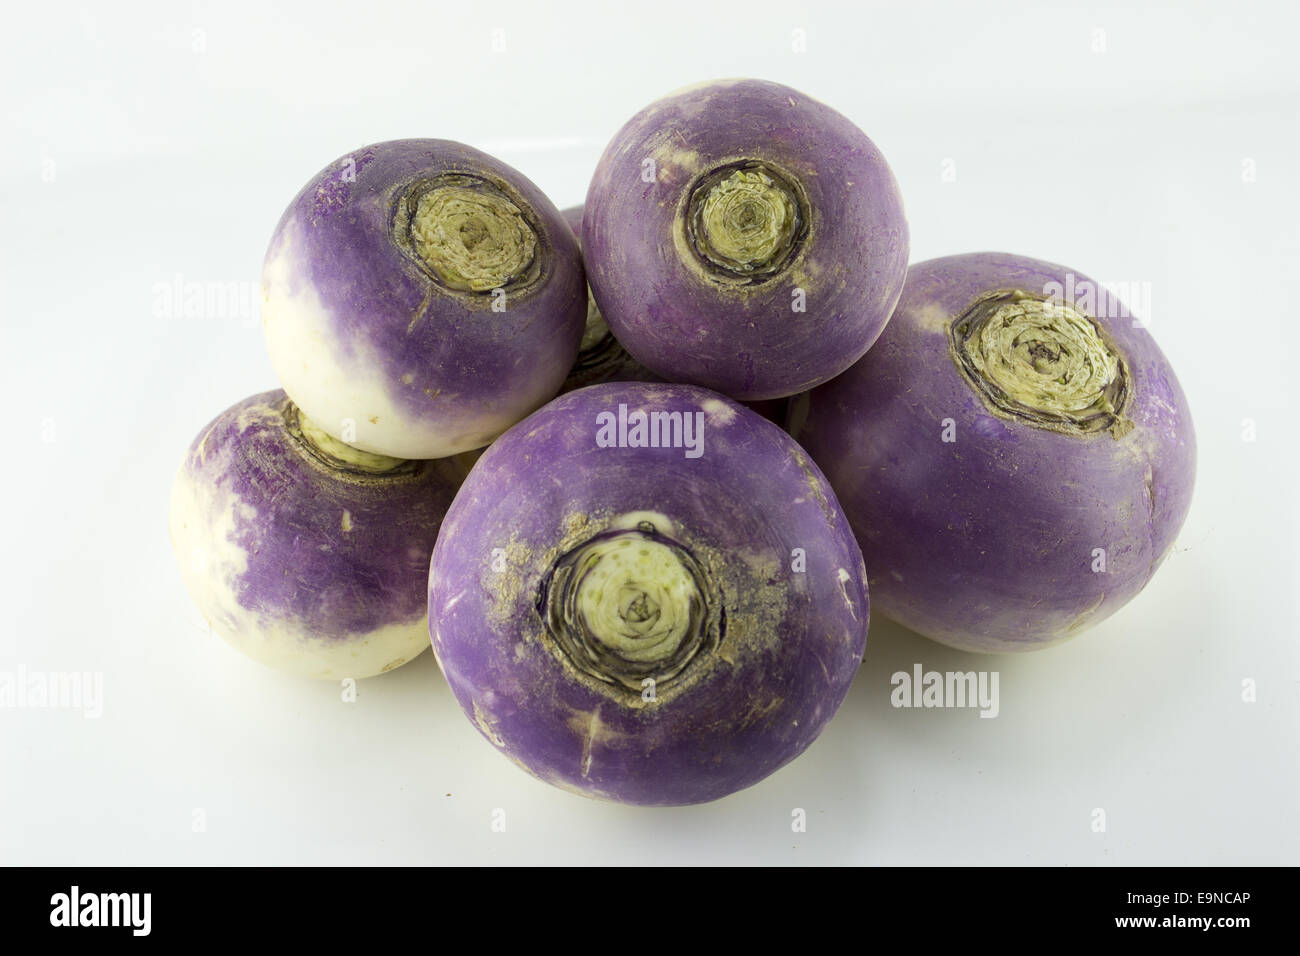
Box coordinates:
[0,0,1300,864]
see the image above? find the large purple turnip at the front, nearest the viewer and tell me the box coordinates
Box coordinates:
[429,382,867,805]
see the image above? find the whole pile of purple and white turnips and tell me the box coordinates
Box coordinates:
[170,81,1195,805]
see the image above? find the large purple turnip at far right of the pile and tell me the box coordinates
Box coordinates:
[792,252,1196,652]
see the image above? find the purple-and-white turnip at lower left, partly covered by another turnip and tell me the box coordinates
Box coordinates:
[170,390,465,680]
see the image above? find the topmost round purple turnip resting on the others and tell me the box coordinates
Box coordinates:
[582,79,907,401]
